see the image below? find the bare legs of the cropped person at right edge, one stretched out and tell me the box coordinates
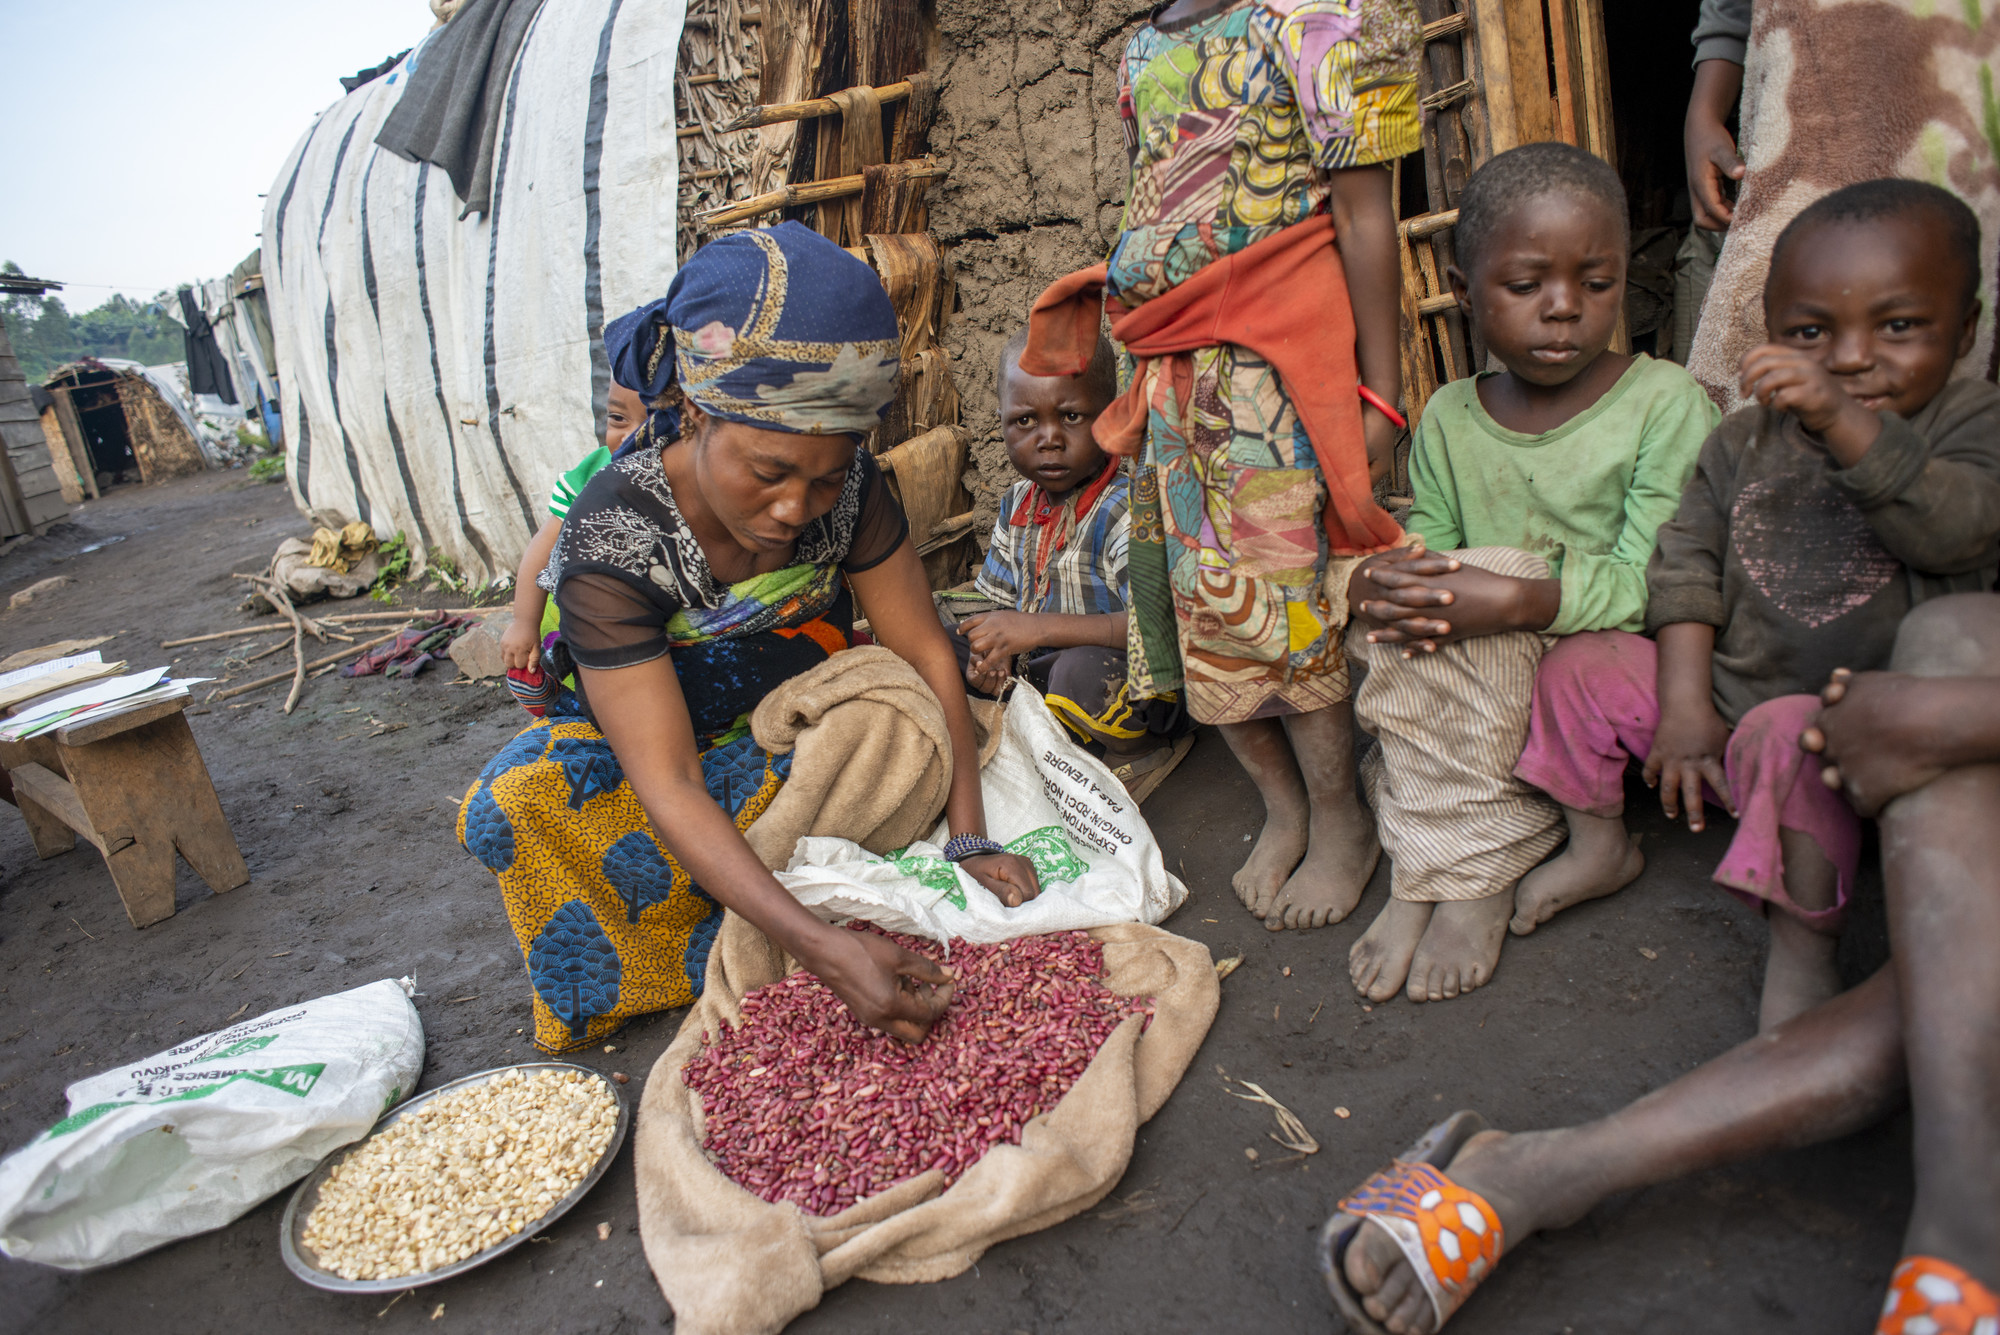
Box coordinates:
[1330,594,2000,1335]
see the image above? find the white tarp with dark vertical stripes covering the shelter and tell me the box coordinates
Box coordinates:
[262,0,684,578]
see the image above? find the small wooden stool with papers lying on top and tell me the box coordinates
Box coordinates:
[0,697,250,927]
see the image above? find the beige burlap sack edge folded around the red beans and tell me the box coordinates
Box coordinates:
[634,911,1222,1335]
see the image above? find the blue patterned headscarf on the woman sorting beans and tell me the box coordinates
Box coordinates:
[604,222,902,436]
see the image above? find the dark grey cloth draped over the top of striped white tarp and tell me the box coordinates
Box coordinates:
[376,0,542,218]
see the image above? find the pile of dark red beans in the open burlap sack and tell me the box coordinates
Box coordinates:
[680,931,1152,1215]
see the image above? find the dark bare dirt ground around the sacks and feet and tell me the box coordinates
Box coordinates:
[0,474,1912,1335]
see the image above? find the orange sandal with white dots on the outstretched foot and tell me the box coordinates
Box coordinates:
[1320,1113,1504,1335]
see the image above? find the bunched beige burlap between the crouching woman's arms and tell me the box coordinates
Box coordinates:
[744,646,1000,871]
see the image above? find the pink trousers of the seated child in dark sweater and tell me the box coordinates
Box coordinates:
[1514,630,1862,931]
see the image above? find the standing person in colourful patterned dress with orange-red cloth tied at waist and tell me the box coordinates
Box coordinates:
[1022,0,1422,929]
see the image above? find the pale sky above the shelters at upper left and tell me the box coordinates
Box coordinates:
[0,0,434,312]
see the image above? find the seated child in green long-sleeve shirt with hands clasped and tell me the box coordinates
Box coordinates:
[1348,144,1718,1001]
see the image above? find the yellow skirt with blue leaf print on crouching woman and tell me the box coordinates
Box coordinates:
[458,691,792,1053]
